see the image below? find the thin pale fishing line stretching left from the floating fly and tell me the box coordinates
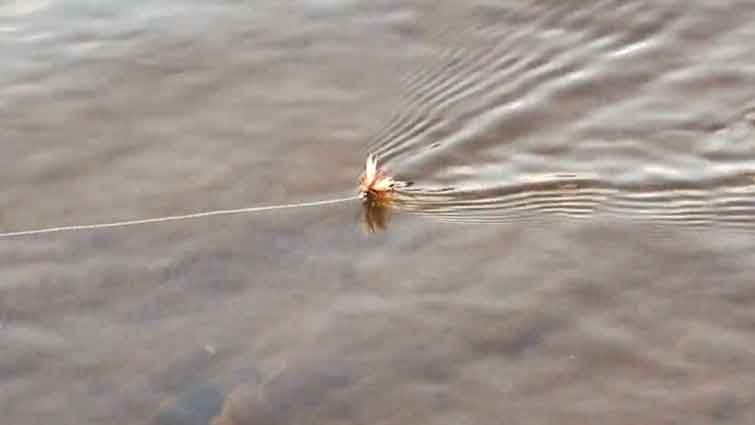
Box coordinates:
[0,196,359,238]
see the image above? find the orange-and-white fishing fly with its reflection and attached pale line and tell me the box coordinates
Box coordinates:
[0,155,408,238]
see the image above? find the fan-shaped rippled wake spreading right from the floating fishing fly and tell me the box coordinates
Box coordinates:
[373,2,755,227]
